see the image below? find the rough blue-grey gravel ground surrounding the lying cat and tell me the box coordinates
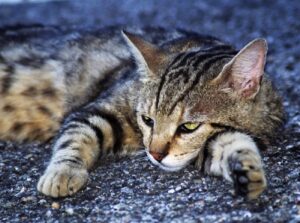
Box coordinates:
[0,0,300,223]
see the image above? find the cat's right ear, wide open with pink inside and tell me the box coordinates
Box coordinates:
[213,39,267,99]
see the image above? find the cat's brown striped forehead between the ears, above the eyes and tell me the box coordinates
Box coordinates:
[154,47,236,114]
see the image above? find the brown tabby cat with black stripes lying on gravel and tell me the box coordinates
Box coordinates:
[0,27,283,199]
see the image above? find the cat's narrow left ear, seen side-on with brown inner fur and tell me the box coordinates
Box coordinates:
[122,31,166,76]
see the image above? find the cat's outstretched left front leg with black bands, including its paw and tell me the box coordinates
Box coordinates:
[37,107,114,197]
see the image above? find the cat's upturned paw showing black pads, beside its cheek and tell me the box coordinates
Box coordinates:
[228,150,267,199]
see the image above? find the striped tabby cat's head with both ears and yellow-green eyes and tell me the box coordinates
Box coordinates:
[124,30,282,171]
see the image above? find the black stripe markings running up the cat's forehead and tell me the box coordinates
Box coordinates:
[156,45,237,114]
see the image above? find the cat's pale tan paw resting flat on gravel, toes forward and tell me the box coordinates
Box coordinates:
[37,165,88,197]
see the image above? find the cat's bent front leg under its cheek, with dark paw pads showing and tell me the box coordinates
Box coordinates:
[205,132,267,199]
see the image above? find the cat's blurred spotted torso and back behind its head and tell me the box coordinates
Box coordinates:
[0,25,225,141]
